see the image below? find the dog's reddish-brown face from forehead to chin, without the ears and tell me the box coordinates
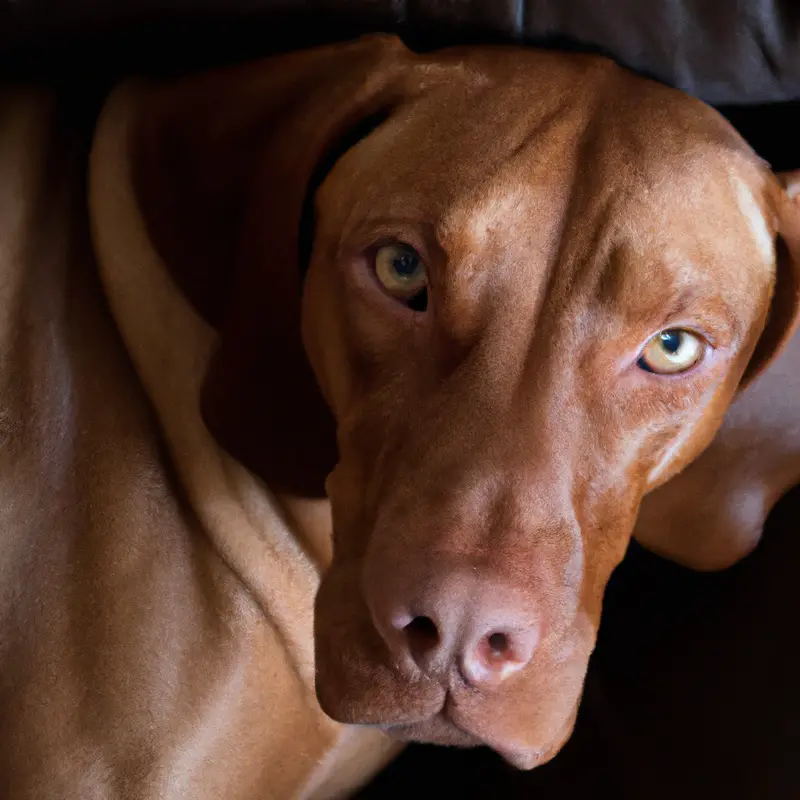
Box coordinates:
[303,54,792,767]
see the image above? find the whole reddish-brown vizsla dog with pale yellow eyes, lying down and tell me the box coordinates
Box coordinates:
[0,37,800,798]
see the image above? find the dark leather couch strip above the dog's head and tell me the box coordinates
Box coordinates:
[0,0,800,104]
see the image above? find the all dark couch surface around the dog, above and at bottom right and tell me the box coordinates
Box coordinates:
[0,0,800,800]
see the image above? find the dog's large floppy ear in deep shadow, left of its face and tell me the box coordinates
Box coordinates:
[132,36,414,496]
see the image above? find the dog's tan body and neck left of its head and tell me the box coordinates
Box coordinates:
[0,86,396,800]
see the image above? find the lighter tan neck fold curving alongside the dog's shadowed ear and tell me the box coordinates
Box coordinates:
[89,84,331,668]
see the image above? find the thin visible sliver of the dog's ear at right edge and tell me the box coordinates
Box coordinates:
[739,170,800,389]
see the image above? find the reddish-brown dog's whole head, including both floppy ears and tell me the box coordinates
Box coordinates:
[134,37,800,767]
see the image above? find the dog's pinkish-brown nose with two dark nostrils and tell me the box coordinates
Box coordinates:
[372,581,540,688]
